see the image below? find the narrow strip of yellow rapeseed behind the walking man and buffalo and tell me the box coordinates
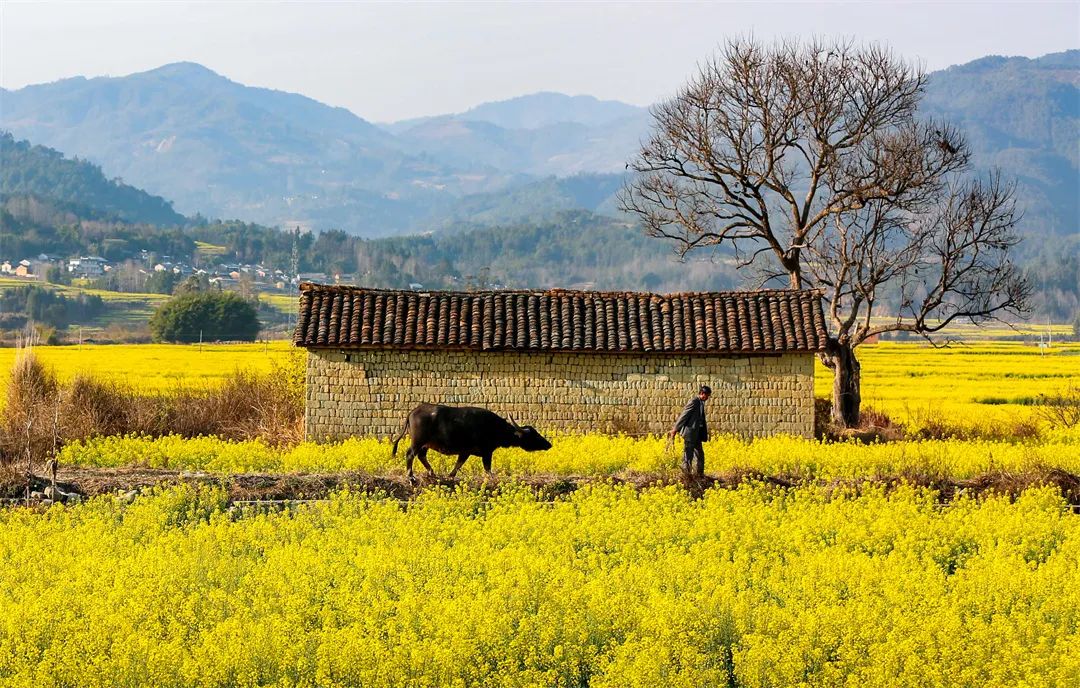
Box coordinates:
[59,431,1080,478]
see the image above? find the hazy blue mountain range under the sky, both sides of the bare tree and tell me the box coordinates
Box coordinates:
[0,51,1080,237]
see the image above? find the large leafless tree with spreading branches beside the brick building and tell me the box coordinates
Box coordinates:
[620,39,1029,427]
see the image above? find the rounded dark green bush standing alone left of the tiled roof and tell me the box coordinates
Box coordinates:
[150,292,259,343]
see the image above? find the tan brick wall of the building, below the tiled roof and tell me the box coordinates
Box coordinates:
[306,349,813,440]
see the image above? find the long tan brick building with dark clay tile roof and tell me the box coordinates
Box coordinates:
[294,283,826,440]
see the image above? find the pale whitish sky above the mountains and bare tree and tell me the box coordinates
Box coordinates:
[0,0,1080,121]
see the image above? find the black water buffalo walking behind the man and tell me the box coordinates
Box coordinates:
[393,404,551,481]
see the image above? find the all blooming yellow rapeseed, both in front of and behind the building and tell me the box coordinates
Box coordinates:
[0,330,1080,688]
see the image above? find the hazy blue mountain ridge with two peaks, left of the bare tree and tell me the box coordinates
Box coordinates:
[0,68,644,235]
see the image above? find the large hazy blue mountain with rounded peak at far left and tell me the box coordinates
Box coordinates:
[0,64,486,234]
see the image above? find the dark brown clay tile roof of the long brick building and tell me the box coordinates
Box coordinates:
[293,282,827,354]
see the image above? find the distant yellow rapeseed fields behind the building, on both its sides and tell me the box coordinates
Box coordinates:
[0,334,1080,428]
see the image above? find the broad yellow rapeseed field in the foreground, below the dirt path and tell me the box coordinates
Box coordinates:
[0,485,1080,688]
